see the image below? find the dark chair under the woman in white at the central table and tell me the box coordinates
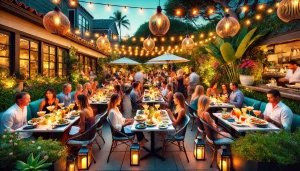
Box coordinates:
[106,117,134,163]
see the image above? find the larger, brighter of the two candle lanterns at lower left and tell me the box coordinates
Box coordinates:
[77,147,92,170]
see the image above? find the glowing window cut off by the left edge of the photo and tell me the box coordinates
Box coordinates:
[0,33,10,77]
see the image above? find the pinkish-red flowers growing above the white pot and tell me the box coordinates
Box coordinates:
[237,58,258,75]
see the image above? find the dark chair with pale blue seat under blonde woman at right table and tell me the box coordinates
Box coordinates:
[198,116,235,167]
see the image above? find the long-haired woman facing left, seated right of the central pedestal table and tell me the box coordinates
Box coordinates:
[167,92,185,130]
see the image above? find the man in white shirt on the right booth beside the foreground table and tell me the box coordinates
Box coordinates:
[261,89,293,131]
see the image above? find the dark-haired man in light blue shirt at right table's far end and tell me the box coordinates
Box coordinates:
[224,82,244,108]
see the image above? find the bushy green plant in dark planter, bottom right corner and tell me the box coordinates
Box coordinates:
[231,129,300,171]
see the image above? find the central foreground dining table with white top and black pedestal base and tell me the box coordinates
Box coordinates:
[131,110,175,160]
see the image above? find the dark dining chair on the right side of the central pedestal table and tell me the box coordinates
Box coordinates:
[162,115,190,162]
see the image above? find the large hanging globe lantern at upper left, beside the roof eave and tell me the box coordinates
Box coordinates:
[43,7,70,35]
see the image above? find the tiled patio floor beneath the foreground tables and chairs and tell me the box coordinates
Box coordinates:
[89,96,218,171]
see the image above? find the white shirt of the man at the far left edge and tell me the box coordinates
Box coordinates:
[0,103,32,138]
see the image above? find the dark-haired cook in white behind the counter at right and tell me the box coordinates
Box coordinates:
[278,60,300,83]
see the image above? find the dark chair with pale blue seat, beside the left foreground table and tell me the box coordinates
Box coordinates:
[65,115,100,163]
